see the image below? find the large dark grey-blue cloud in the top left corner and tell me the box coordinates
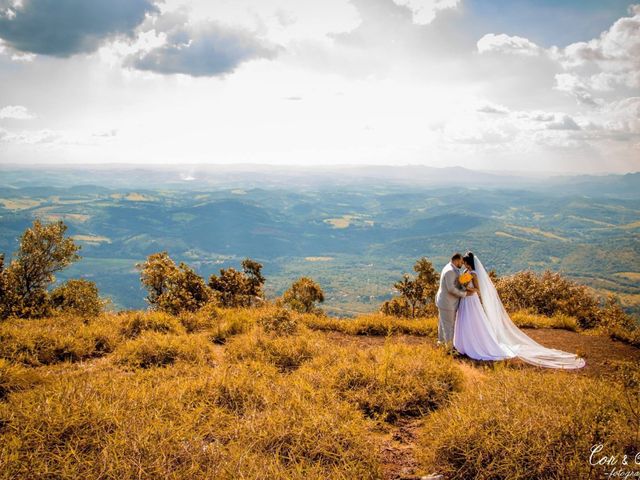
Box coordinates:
[0,0,157,57]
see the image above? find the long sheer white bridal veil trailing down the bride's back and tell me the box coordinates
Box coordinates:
[474,257,585,369]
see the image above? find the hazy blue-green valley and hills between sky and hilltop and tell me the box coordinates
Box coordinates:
[0,165,640,315]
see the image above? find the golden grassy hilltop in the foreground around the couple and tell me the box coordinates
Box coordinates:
[0,306,640,479]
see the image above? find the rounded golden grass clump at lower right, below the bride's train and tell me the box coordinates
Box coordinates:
[417,369,640,480]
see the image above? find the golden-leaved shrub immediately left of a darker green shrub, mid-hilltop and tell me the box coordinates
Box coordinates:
[136,251,213,315]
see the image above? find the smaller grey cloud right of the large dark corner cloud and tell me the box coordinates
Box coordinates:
[128,22,278,77]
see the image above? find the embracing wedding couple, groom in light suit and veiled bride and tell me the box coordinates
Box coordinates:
[436,252,585,369]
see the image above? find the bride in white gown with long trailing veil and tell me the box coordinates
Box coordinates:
[453,252,585,369]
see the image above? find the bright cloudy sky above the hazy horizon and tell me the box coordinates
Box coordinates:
[0,0,640,173]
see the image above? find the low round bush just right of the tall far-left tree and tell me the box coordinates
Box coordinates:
[50,279,105,317]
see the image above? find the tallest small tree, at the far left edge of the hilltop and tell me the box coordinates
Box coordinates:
[0,219,80,318]
